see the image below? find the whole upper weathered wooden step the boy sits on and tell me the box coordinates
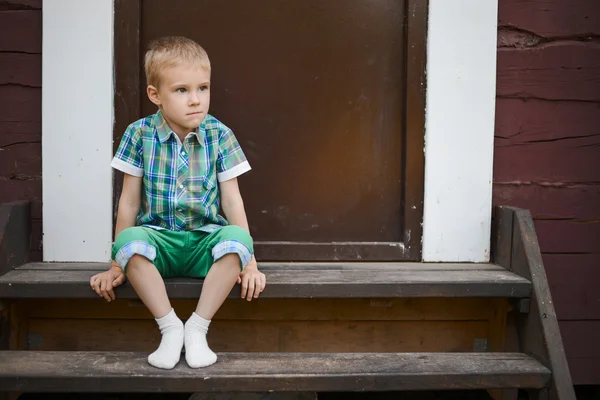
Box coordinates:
[0,262,531,299]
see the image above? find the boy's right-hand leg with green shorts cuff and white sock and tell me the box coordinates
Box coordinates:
[185,226,253,368]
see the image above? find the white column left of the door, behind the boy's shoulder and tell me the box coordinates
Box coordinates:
[42,0,114,261]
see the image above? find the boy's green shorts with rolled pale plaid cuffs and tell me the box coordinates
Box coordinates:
[112,225,254,278]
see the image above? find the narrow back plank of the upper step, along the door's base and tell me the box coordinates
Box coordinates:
[18,262,503,272]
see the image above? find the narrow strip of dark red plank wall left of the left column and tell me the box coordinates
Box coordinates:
[0,0,42,260]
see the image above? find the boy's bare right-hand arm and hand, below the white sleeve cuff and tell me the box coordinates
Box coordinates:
[219,178,266,300]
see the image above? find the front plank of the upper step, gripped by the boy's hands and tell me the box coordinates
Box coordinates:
[0,269,531,299]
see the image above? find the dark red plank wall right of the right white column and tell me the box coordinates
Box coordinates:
[494,0,600,384]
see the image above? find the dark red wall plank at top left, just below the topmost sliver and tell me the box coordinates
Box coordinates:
[0,10,42,54]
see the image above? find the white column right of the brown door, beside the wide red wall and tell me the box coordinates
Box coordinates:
[423,0,498,262]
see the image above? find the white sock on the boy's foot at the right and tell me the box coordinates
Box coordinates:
[185,313,217,368]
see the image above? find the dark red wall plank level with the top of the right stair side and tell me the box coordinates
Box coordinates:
[493,182,600,220]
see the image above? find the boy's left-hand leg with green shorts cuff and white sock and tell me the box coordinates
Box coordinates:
[113,227,184,369]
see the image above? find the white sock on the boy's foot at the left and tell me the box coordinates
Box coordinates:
[148,309,183,369]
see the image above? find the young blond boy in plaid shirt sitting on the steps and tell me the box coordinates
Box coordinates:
[90,37,266,369]
